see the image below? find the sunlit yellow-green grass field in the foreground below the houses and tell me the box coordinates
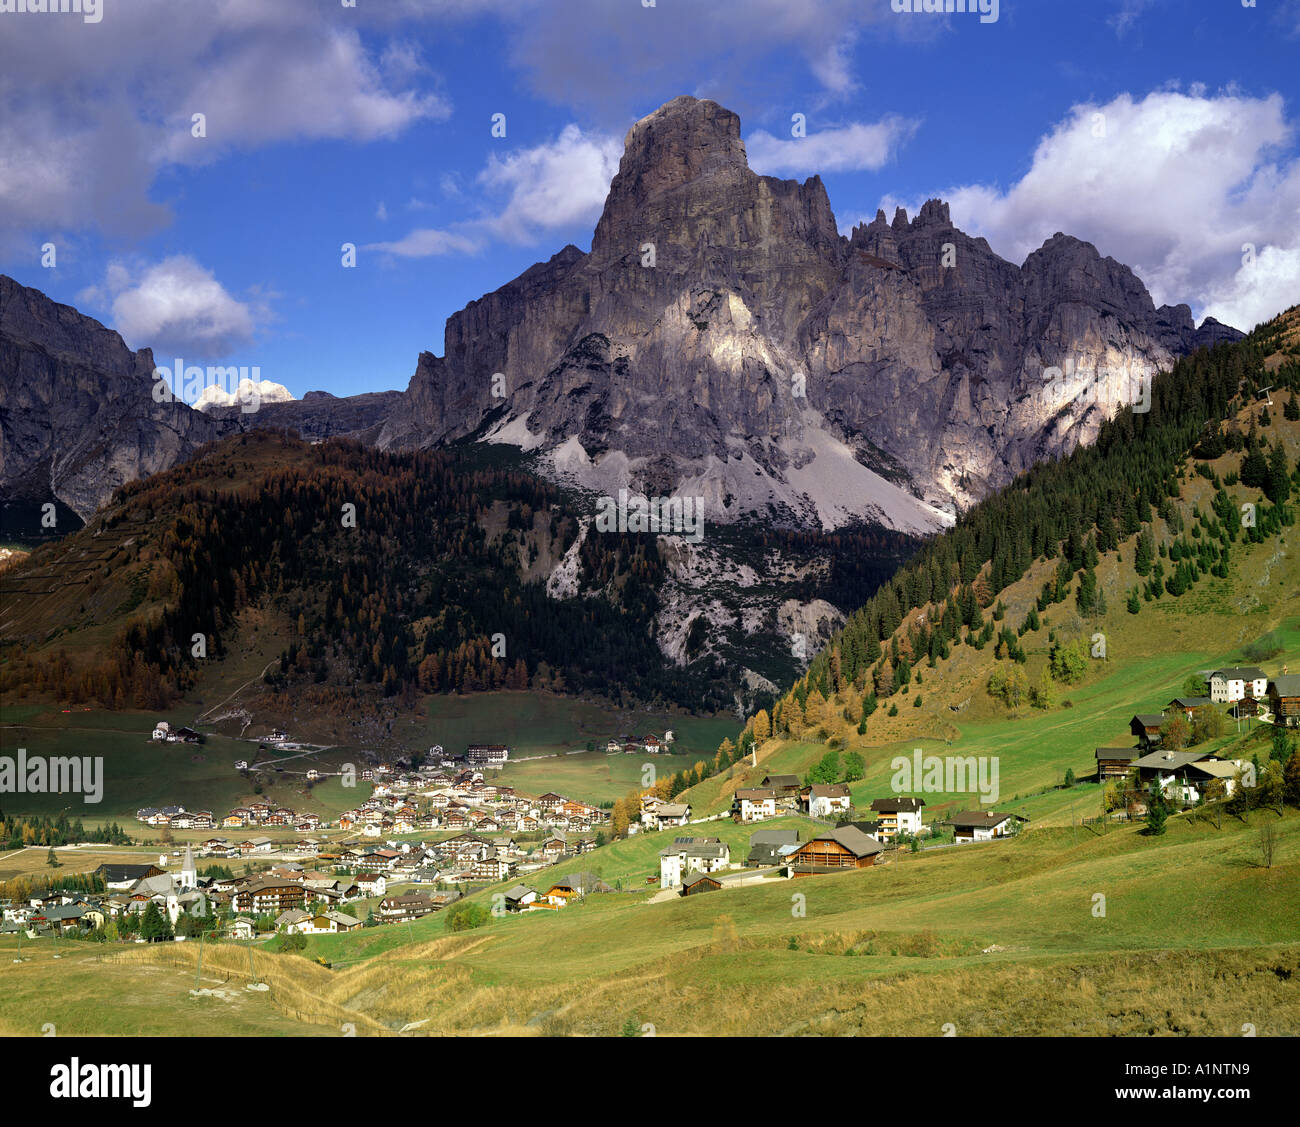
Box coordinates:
[0,812,1300,1036]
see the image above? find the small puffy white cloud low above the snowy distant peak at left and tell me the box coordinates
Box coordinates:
[78,255,270,359]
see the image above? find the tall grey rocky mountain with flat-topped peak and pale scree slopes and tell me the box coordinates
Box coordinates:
[378,97,1240,532]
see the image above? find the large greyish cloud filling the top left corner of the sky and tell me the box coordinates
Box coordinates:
[0,0,450,244]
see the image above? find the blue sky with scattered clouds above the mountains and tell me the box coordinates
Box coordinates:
[0,0,1300,395]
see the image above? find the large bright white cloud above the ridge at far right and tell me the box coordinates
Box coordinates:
[944,90,1300,329]
